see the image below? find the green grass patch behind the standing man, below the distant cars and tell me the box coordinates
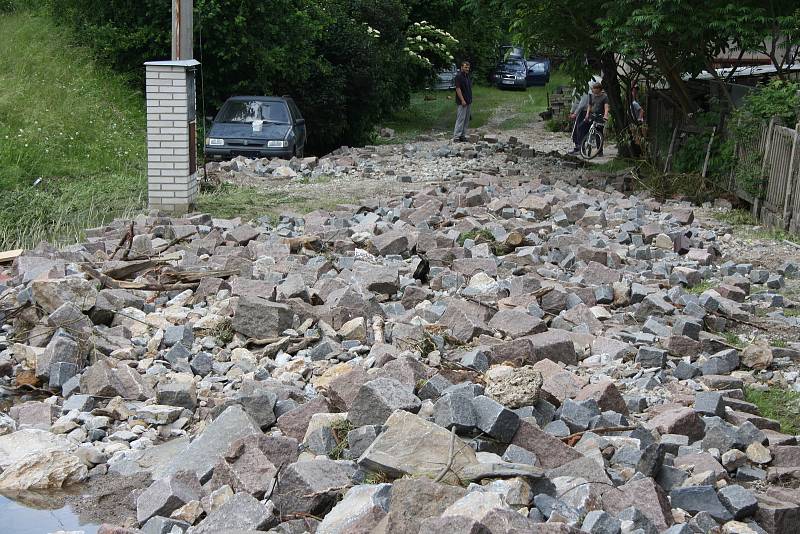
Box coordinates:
[382,73,568,143]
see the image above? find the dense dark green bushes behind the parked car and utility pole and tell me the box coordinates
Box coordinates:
[47,0,418,152]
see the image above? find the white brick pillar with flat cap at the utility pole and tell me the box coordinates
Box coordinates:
[145,60,200,214]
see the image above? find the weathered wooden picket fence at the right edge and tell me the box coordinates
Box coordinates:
[740,119,800,232]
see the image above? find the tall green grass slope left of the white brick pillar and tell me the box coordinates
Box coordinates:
[0,12,147,250]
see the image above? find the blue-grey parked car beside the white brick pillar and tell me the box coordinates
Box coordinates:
[205,96,306,160]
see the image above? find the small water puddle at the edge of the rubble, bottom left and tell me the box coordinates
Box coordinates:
[0,494,100,534]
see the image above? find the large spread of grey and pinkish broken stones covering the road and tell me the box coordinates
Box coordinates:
[0,140,800,534]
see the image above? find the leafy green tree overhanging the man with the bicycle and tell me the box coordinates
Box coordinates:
[496,0,800,158]
